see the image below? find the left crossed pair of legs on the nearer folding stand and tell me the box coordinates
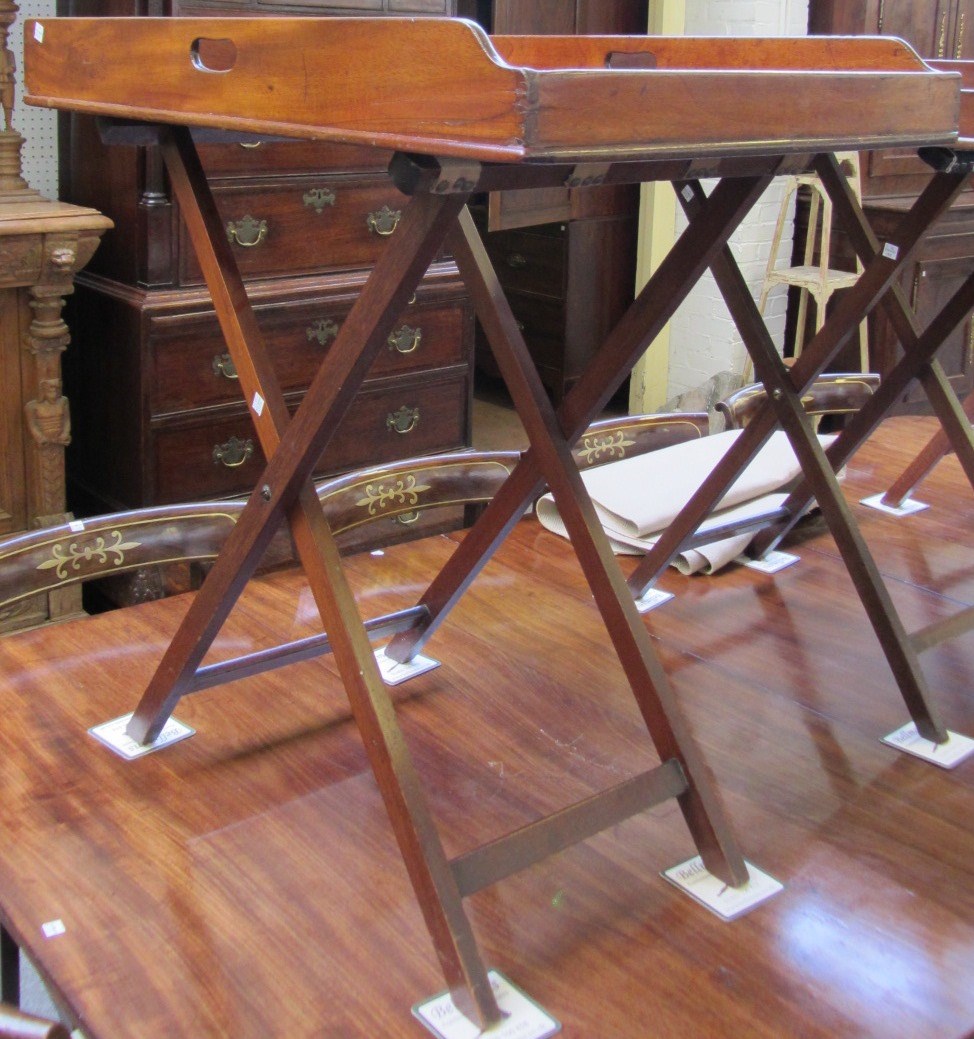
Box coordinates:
[117,129,500,1024]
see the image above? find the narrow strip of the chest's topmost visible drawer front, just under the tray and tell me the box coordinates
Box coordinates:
[200,140,392,177]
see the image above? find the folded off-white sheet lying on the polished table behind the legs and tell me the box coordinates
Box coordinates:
[535,429,835,574]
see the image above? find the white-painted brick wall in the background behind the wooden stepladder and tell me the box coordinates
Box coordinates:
[668,0,808,397]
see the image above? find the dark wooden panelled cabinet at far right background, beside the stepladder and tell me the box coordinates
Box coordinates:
[795,0,974,411]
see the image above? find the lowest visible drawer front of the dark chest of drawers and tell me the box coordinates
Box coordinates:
[151,374,469,505]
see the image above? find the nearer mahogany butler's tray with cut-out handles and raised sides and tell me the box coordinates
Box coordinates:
[25,18,960,162]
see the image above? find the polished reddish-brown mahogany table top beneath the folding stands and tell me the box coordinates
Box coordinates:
[0,419,974,1039]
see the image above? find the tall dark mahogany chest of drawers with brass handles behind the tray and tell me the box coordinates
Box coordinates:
[58,0,473,515]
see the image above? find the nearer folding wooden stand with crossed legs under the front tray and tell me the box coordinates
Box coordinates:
[115,129,806,1024]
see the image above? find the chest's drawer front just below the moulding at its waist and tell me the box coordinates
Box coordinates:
[149,299,471,417]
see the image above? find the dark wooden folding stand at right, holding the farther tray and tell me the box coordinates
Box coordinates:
[629,149,974,760]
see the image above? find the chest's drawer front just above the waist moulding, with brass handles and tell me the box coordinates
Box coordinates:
[180,176,407,285]
